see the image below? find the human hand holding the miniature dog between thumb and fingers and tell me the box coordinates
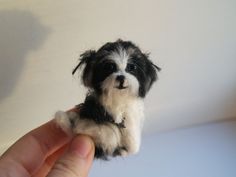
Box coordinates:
[0,120,95,177]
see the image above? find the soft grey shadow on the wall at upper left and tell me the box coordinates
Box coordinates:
[0,10,50,101]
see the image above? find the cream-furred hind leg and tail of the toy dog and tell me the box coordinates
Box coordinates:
[55,111,121,156]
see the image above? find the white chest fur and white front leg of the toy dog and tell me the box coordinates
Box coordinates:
[100,91,144,155]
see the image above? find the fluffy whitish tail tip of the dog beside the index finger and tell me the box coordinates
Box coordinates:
[55,111,72,135]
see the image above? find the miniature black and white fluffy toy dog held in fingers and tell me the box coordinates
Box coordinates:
[56,40,160,159]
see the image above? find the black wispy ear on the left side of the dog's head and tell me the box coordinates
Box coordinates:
[72,50,96,87]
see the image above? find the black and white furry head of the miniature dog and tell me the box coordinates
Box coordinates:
[73,40,160,97]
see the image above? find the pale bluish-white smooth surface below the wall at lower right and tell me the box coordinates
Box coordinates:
[89,121,236,177]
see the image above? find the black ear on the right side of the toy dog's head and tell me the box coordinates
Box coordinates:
[143,54,161,96]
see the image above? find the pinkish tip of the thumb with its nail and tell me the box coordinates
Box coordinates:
[69,135,93,158]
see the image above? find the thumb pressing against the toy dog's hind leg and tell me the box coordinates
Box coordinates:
[48,135,95,177]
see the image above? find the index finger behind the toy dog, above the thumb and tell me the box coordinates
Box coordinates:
[1,120,71,175]
